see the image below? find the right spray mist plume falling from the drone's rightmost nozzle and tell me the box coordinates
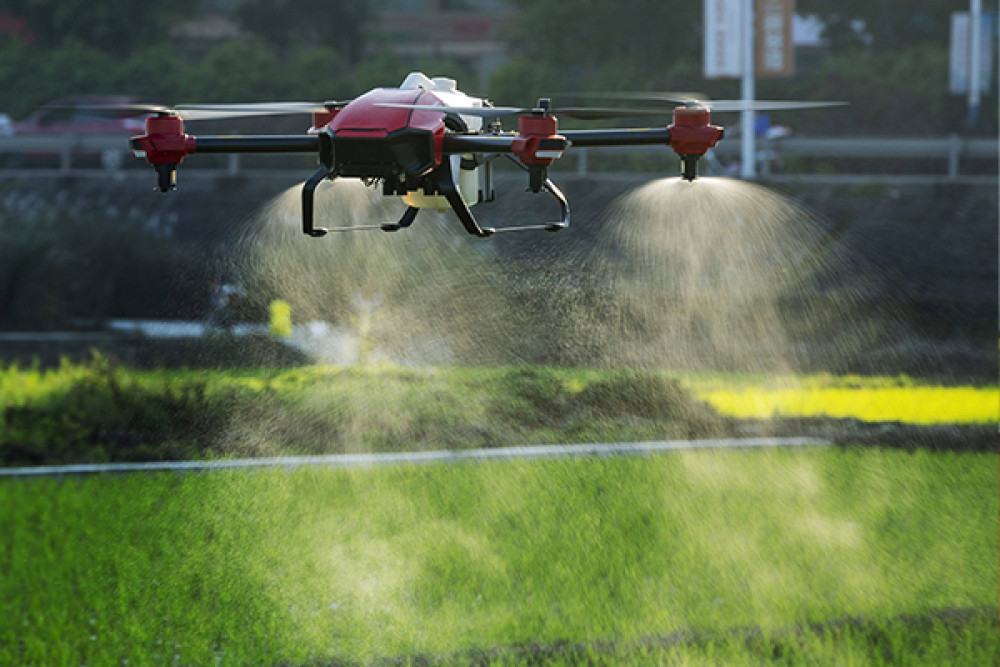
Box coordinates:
[596,178,872,372]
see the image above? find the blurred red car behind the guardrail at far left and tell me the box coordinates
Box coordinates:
[11,95,145,169]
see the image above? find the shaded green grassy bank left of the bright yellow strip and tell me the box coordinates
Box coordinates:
[0,358,727,464]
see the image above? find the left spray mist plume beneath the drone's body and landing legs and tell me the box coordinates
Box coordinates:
[231,179,504,364]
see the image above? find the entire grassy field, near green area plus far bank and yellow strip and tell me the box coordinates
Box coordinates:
[0,360,1000,665]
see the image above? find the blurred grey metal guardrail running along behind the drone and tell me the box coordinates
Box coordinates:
[0,134,1000,180]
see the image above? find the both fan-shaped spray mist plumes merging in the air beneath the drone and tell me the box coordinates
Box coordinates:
[225,172,858,371]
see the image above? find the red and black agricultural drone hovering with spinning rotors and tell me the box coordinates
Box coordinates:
[128,72,844,237]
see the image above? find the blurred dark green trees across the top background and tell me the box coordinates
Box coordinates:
[0,0,997,135]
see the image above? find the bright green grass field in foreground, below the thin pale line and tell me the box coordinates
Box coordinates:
[0,449,1000,665]
